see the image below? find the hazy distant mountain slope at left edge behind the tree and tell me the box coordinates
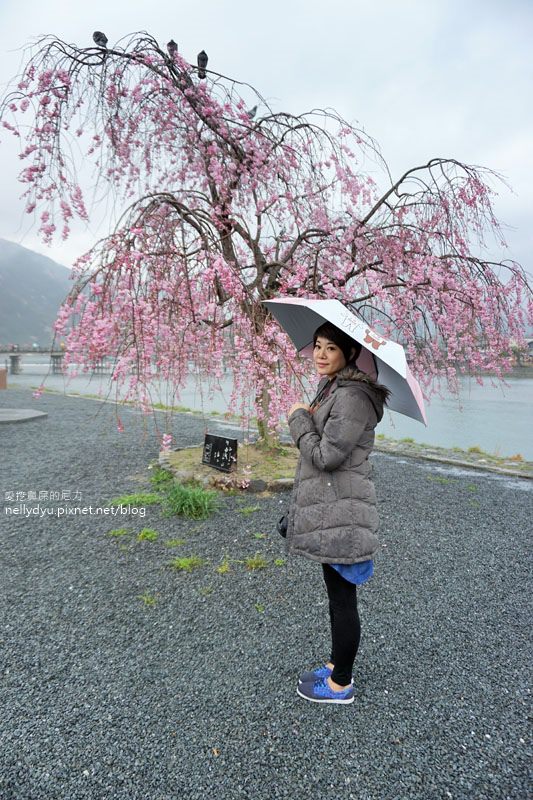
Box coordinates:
[0,239,72,347]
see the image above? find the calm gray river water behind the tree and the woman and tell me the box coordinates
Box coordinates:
[8,354,533,461]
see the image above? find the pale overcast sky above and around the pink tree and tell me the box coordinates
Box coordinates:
[0,0,533,273]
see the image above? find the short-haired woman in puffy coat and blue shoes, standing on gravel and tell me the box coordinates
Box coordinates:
[287,323,389,704]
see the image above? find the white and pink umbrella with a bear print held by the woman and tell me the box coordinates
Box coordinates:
[263,297,427,425]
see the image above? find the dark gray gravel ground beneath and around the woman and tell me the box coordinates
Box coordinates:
[0,389,533,800]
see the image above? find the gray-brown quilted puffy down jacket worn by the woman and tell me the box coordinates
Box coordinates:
[287,367,388,564]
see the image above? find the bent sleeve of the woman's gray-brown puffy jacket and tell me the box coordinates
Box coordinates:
[289,389,371,472]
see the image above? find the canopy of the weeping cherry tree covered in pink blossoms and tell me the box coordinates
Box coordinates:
[2,33,531,438]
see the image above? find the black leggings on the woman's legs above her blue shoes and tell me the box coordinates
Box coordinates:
[322,564,361,686]
